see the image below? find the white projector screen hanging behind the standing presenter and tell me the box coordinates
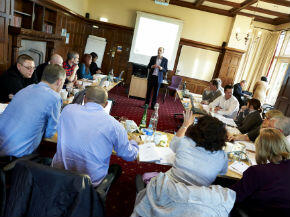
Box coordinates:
[129,11,183,70]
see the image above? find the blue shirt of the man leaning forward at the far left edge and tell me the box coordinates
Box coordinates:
[0,82,62,157]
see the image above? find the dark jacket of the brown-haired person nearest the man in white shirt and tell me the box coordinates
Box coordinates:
[238,111,263,134]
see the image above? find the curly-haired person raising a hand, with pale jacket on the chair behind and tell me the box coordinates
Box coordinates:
[131,111,235,217]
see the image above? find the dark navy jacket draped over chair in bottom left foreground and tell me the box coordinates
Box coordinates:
[4,160,104,217]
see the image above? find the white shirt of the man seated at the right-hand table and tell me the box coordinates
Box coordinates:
[209,96,239,118]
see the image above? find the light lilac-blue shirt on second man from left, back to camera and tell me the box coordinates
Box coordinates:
[52,102,138,186]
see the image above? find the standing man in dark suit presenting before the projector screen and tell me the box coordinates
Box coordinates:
[144,47,168,109]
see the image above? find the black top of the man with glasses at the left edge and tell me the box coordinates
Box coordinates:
[0,65,38,102]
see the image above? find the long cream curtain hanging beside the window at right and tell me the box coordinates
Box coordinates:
[236,28,281,91]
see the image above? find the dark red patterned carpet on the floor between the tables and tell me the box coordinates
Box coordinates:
[106,87,183,217]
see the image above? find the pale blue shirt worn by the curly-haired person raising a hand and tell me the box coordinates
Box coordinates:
[167,136,228,186]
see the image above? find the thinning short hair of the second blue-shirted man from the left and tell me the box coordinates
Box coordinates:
[86,86,108,104]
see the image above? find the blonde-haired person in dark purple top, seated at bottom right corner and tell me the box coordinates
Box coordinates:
[231,128,290,216]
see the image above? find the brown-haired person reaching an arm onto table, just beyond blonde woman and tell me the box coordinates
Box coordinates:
[228,109,284,142]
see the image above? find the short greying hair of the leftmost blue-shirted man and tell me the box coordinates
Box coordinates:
[41,64,66,84]
